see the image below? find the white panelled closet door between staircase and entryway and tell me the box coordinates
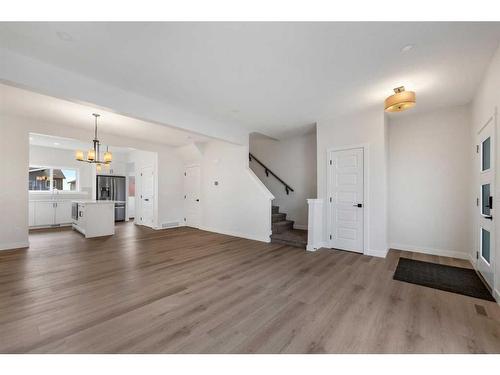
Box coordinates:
[327,148,364,253]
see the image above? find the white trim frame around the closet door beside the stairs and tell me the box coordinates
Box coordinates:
[325,143,370,255]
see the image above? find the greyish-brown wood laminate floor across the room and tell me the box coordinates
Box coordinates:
[0,223,500,353]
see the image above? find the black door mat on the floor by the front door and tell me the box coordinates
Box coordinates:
[393,258,495,302]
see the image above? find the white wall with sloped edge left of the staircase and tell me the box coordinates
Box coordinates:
[178,141,274,242]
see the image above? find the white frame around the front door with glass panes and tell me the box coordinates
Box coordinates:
[471,108,500,298]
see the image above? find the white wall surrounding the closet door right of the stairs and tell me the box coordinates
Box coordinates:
[316,109,388,256]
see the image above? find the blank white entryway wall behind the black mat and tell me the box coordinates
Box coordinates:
[389,106,473,259]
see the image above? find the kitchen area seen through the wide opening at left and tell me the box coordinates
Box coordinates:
[28,134,139,238]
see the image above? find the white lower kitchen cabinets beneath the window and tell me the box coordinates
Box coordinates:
[29,200,72,227]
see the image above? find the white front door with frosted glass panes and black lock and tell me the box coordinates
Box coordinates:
[477,118,496,288]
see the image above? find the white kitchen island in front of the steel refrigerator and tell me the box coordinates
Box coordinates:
[72,200,115,238]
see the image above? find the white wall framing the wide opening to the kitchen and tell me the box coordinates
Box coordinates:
[0,113,183,249]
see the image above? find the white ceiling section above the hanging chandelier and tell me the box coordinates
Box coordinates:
[0,84,211,149]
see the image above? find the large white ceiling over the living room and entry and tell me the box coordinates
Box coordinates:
[0,22,500,137]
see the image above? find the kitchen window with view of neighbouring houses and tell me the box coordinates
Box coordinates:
[28,167,78,192]
